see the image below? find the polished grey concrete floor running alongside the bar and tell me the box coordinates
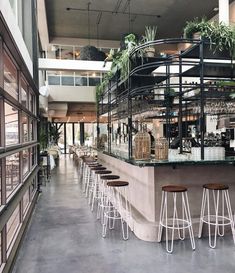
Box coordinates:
[13,156,235,273]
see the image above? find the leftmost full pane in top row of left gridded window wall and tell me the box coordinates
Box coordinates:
[3,52,18,100]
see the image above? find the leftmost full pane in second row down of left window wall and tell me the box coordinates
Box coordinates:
[5,103,19,146]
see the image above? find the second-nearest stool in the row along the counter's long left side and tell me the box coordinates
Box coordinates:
[97,174,120,224]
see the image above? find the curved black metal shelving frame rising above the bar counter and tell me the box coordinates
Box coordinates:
[97,39,235,160]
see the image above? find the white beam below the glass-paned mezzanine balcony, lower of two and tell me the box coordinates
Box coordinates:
[49,85,96,102]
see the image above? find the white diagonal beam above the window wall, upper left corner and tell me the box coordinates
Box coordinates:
[0,0,33,76]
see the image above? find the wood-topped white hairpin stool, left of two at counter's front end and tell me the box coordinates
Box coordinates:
[158,185,195,253]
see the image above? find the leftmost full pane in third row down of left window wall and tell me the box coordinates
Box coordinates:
[6,153,20,197]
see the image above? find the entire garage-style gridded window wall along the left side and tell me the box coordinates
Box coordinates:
[0,26,38,272]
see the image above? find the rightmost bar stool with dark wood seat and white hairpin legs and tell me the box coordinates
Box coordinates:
[198,183,235,248]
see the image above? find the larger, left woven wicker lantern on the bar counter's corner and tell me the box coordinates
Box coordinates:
[134,127,151,160]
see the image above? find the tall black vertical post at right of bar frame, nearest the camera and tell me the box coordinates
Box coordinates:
[200,40,205,160]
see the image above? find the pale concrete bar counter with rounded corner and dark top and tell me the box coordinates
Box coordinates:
[98,152,235,242]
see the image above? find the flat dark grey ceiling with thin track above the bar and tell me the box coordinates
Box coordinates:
[45,0,222,40]
